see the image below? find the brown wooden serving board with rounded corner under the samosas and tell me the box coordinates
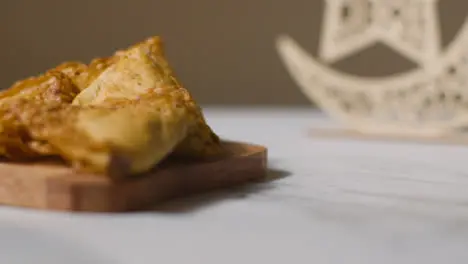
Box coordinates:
[0,142,267,212]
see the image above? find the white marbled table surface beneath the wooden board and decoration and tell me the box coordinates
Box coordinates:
[0,108,468,264]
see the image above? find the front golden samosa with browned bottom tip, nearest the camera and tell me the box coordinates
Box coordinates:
[21,93,192,177]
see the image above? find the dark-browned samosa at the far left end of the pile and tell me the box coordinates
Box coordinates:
[0,71,79,160]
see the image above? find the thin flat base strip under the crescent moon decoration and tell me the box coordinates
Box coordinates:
[309,128,468,145]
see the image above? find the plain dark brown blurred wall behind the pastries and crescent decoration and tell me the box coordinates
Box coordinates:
[0,0,468,105]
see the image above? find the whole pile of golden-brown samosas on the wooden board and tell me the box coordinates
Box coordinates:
[0,34,224,175]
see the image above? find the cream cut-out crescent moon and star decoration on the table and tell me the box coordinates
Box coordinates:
[276,0,468,136]
